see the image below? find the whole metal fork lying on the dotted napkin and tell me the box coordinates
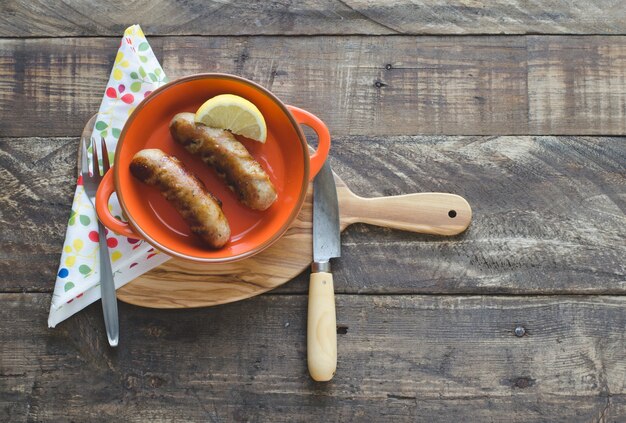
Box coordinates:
[81,137,120,347]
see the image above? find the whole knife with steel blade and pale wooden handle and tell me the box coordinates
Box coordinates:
[307,160,341,382]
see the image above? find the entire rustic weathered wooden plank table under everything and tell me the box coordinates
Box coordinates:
[0,0,626,422]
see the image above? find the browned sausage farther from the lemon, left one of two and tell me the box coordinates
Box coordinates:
[130,149,230,248]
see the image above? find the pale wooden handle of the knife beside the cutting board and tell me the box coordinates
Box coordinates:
[307,272,337,382]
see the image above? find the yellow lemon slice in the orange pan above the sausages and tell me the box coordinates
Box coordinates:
[195,94,267,143]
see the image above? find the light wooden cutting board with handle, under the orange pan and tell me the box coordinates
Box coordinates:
[117,174,472,308]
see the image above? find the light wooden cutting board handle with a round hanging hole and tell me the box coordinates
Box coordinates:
[340,192,472,235]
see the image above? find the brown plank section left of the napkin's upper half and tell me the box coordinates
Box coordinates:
[0,38,126,137]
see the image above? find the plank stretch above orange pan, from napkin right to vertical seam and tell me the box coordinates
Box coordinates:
[163,37,528,136]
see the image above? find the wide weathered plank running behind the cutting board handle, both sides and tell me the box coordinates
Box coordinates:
[0,136,626,294]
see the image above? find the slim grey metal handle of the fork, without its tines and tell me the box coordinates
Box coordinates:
[98,221,120,347]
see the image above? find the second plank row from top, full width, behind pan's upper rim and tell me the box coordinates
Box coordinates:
[0,36,626,136]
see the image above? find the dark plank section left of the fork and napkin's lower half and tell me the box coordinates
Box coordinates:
[0,138,78,292]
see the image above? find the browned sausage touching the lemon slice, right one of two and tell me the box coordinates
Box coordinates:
[170,113,278,210]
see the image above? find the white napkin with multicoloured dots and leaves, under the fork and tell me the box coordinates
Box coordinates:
[48,25,169,327]
